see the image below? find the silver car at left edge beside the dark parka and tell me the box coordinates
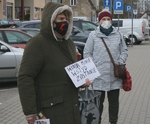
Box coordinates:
[0,41,24,82]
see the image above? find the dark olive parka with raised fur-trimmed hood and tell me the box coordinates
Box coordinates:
[18,2,81,124]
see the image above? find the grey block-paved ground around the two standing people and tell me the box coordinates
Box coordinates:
[0,41,150,124]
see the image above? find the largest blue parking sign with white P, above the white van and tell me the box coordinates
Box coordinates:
[114,0,123,14]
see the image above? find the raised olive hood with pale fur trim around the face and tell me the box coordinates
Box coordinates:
[40,2,73,40]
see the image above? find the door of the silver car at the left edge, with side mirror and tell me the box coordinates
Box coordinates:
[0,43,16,78]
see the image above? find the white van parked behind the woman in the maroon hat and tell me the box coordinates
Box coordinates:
[112,18,149,44]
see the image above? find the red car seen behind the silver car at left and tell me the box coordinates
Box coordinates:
[0,28,33,48]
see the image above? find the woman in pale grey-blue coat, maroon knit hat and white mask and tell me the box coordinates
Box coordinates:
[84,9,128,124]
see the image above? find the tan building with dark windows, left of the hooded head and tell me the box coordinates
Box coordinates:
[0,0,45,20]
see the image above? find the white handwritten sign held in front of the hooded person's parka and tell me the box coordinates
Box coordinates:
[65,57,100,87]
